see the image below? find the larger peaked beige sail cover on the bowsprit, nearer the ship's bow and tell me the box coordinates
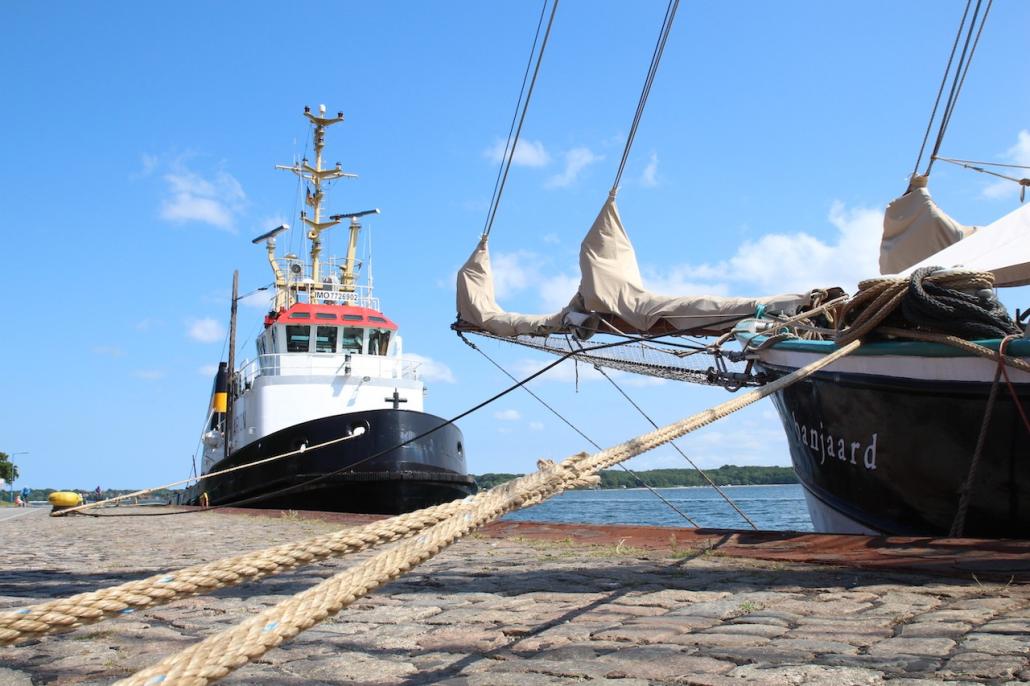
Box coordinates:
[579,194,811,331]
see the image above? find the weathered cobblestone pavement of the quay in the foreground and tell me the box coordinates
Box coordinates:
[0,510,1030,686]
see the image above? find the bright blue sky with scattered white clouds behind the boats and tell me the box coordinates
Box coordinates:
[0,0,1030,488]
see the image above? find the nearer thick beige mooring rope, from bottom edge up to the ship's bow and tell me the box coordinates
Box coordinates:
[117,341,861,686]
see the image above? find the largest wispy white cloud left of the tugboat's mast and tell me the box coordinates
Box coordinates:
[161,161,246,233]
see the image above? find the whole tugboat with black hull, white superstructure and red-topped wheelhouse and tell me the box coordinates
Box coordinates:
[185,105,476,514]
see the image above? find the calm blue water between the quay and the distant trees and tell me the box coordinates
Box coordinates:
[505,484,812,531]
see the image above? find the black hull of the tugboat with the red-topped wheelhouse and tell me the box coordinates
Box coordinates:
[186,410,476,514]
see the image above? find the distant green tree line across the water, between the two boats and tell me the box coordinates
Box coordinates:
[476,465,797,488]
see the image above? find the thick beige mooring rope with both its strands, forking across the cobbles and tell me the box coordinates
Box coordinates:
[0,341,860,686]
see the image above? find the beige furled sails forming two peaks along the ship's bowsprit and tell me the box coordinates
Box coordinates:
[457,194,811,337]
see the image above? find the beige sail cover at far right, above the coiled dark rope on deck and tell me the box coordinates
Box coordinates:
[880,187,976,274]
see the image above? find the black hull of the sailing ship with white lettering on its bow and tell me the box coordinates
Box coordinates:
[762,365,1030,539]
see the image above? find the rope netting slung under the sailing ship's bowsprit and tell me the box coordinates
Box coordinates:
[471,331,744,385]
